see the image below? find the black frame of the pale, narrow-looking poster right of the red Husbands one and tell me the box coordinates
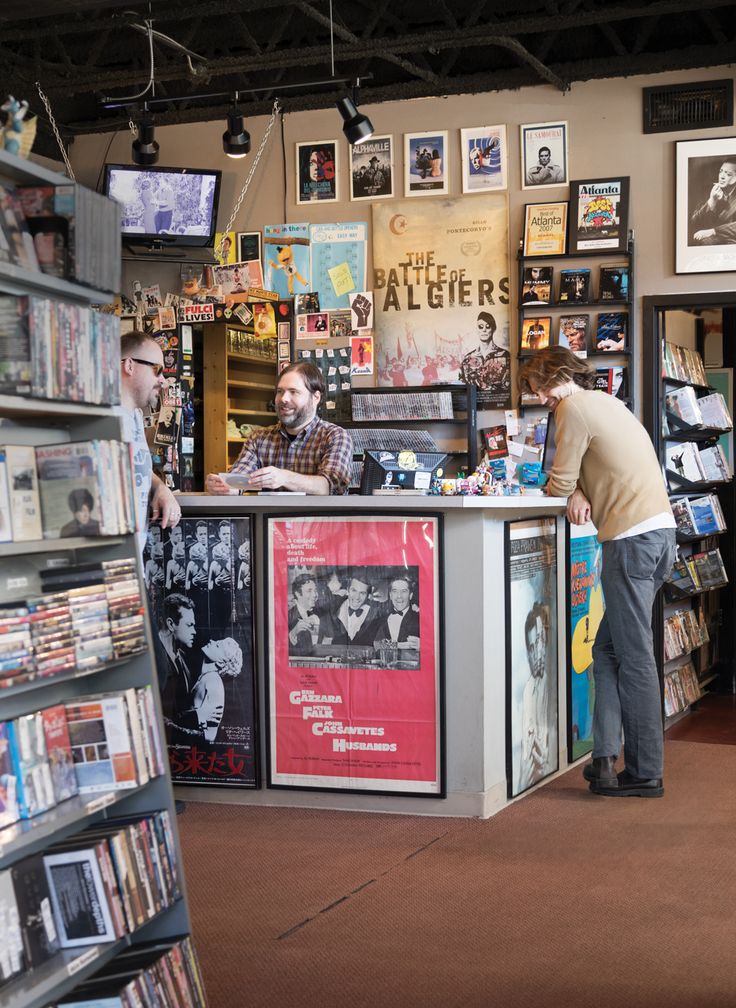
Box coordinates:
[503,516,560,800]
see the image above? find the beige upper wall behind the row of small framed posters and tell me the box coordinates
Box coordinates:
[72,61,736,397]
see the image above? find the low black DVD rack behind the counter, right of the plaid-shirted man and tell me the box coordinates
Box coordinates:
[340,383,479,490]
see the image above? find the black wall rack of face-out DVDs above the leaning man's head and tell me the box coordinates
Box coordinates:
[518,238,636,408]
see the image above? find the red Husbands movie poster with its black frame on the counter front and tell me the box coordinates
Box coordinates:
[266,514,446,797]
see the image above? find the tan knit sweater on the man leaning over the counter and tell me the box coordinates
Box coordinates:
[547,388,669,542]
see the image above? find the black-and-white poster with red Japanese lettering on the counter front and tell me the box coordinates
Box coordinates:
[143,518,257,787]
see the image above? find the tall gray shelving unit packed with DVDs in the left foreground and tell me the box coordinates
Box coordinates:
[0,153,205,1008]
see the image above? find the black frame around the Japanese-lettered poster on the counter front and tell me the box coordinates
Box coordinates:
[144,512,262,791]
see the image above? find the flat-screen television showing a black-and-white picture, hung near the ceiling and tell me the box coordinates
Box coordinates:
[104,164,222,248]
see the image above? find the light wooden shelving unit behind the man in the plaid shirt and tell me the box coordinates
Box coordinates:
[202,322,278,474]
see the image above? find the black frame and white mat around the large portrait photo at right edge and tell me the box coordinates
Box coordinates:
[674,136,736,273]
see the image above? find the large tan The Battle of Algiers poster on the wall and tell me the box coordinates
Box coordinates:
[373,193,511,409]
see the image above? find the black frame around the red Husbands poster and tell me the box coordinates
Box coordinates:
[262,509,447,798]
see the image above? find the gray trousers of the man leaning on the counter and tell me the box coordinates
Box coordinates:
[593,528,676,778]
